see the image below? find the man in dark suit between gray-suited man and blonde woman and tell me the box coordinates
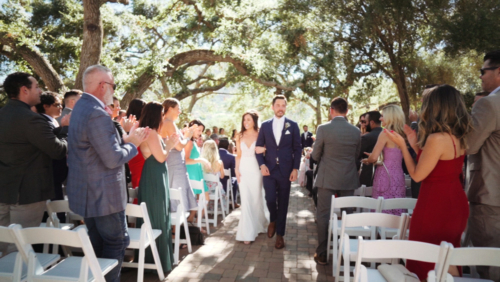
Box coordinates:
[357,111,382,187]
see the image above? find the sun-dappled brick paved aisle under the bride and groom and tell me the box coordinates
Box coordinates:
[122,184,334,282]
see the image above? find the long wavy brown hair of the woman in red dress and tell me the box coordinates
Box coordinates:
[418,84,472,149]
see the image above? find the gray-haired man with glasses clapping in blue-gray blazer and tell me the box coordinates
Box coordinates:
[66,65,149,281]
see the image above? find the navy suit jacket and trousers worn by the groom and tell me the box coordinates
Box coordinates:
[256,118,302,236]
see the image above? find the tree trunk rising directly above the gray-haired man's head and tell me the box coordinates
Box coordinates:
[75,0,105,89]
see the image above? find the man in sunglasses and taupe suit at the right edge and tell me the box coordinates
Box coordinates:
[467,50,500,281]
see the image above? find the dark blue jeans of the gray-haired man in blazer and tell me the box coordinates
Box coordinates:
[85,211,130,282]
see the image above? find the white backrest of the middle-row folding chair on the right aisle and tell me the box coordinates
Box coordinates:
[342,211,406,230]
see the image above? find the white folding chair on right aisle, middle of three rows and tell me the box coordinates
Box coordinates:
[333,211,407,281]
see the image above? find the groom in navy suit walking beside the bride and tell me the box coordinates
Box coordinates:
[256,95,301,249]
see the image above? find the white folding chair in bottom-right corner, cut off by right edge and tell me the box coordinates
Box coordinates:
[436,243,500,282]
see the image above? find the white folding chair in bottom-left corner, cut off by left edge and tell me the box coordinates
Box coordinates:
[0,224,60,281]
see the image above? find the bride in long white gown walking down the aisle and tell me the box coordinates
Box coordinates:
[236,110,267,245]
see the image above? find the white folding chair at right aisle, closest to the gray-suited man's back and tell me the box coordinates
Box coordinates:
[326,196,383,266]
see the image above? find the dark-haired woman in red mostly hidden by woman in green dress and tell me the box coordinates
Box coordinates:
[126,99,146,189]
